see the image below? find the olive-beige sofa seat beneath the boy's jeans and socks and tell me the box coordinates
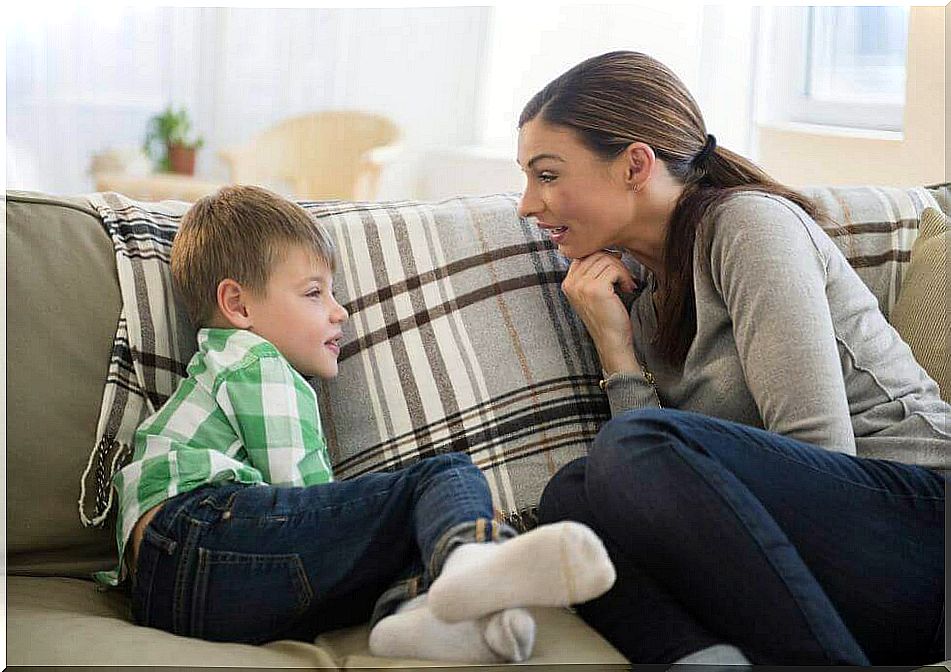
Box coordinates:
[7,576,627,670]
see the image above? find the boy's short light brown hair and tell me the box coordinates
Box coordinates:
[171,185,335,328]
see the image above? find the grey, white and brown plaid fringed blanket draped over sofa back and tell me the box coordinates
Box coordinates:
[79,187,936,529]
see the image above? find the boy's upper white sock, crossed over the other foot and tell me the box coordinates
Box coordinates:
[429,521,616,622]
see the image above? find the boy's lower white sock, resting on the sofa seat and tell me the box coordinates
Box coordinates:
[370,595,535,663]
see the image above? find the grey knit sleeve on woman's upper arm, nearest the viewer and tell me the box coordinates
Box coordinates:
[708,193,855,455]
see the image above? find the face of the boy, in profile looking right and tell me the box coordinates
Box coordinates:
[245,247,348,378]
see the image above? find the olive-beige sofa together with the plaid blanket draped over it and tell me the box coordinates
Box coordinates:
[6,185,951,670]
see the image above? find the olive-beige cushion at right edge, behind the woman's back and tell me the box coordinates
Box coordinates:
[892,208,951,401]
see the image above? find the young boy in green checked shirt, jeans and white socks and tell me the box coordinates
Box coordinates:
[106,186,614,662]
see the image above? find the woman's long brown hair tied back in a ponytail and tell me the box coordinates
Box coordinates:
[518,51,823,365]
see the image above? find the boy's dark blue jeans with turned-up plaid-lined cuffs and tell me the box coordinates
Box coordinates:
[132,453,515,643]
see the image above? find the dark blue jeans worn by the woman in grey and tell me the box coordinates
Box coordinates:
[539,409,945,665]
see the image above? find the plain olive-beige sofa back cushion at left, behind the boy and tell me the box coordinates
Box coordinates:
[6,192,119,576]
